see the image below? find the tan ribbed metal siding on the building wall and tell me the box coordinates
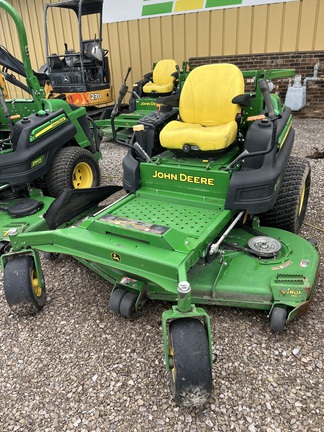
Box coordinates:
[0,0,318,104]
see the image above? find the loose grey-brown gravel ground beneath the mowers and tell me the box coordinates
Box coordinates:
[0,119,324,432]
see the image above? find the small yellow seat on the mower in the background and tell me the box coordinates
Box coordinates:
[143,59,177,94]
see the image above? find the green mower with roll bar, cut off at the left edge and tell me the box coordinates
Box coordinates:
[0,0,101,204]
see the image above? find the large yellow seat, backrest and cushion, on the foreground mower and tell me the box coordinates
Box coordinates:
[160,63,244,151]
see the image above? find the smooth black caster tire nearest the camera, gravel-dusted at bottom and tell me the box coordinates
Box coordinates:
[169,318,212,407]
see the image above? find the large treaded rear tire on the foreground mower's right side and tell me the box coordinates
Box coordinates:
[260,156,311,234]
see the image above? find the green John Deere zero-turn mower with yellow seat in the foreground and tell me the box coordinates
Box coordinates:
[0,64,319,406]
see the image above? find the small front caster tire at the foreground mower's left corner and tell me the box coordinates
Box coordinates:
[3,255,46,316]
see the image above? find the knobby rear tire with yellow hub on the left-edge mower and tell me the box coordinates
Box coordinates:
[45,147,100,197]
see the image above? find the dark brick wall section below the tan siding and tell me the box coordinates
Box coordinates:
[189,51,324,118]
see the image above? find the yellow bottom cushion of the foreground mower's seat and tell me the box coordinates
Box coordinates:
[160,120,237,151]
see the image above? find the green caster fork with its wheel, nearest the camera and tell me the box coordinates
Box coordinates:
[162,282,214,406]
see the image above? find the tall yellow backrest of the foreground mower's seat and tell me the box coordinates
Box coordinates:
[179,63,244,126]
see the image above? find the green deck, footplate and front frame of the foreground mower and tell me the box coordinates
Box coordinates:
[2,150,319,318]
